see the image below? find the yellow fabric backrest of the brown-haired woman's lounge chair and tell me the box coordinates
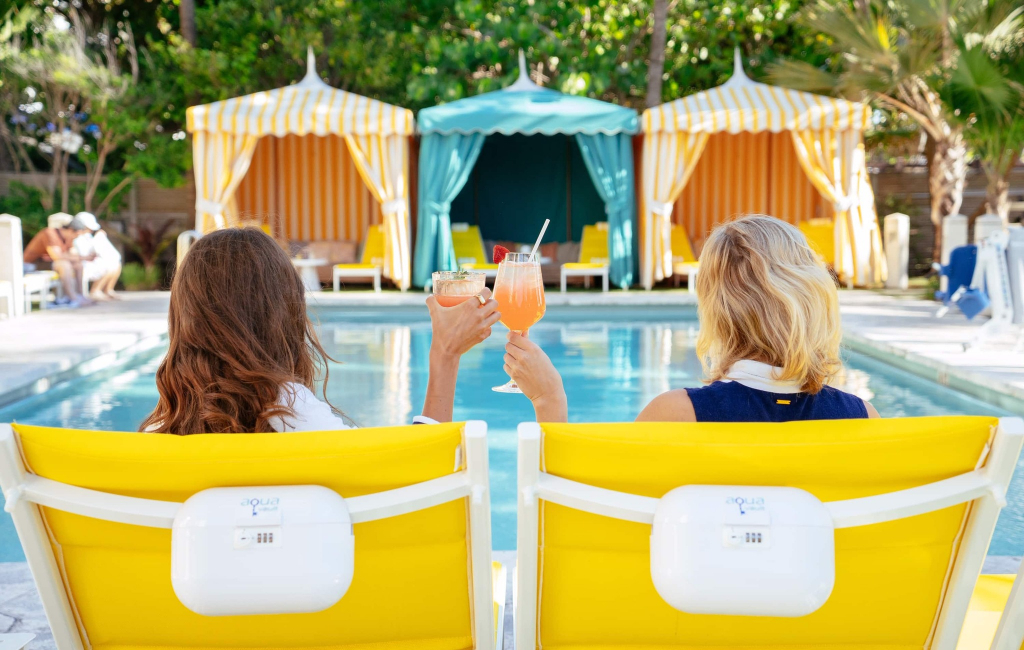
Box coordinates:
[0,424,490,650]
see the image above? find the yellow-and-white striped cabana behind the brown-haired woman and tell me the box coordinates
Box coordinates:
[186,50,415,290]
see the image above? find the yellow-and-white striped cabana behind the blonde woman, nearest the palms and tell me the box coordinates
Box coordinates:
[640,48,886,289]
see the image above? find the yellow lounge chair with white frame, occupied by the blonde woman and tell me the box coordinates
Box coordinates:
[515,417,1024,650]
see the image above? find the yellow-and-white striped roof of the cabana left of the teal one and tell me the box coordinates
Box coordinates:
[185,48,416,136]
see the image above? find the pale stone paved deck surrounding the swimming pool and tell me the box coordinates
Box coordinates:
[0,291,1024,650]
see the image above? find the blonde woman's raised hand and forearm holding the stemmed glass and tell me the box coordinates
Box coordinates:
[505,332,568,422]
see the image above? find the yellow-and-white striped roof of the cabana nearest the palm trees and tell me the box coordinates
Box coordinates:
[643,47,870,133]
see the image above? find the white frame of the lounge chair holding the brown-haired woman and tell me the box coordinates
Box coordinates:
[0,421,495,650]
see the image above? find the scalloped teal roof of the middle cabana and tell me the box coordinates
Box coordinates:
[417,52,639,135]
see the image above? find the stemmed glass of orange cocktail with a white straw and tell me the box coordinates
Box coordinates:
[493,253,546,393]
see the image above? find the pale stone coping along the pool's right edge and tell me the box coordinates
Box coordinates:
[843,332,1024,413]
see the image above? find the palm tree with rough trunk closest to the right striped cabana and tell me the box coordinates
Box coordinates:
[769,0,1022,260]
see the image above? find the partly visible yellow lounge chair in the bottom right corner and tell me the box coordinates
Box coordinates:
[956,565,1024,650]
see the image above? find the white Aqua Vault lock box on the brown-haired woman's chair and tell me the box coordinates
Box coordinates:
[171,485,355,616]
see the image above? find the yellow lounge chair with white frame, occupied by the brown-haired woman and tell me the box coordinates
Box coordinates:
[0,422,504,650]
